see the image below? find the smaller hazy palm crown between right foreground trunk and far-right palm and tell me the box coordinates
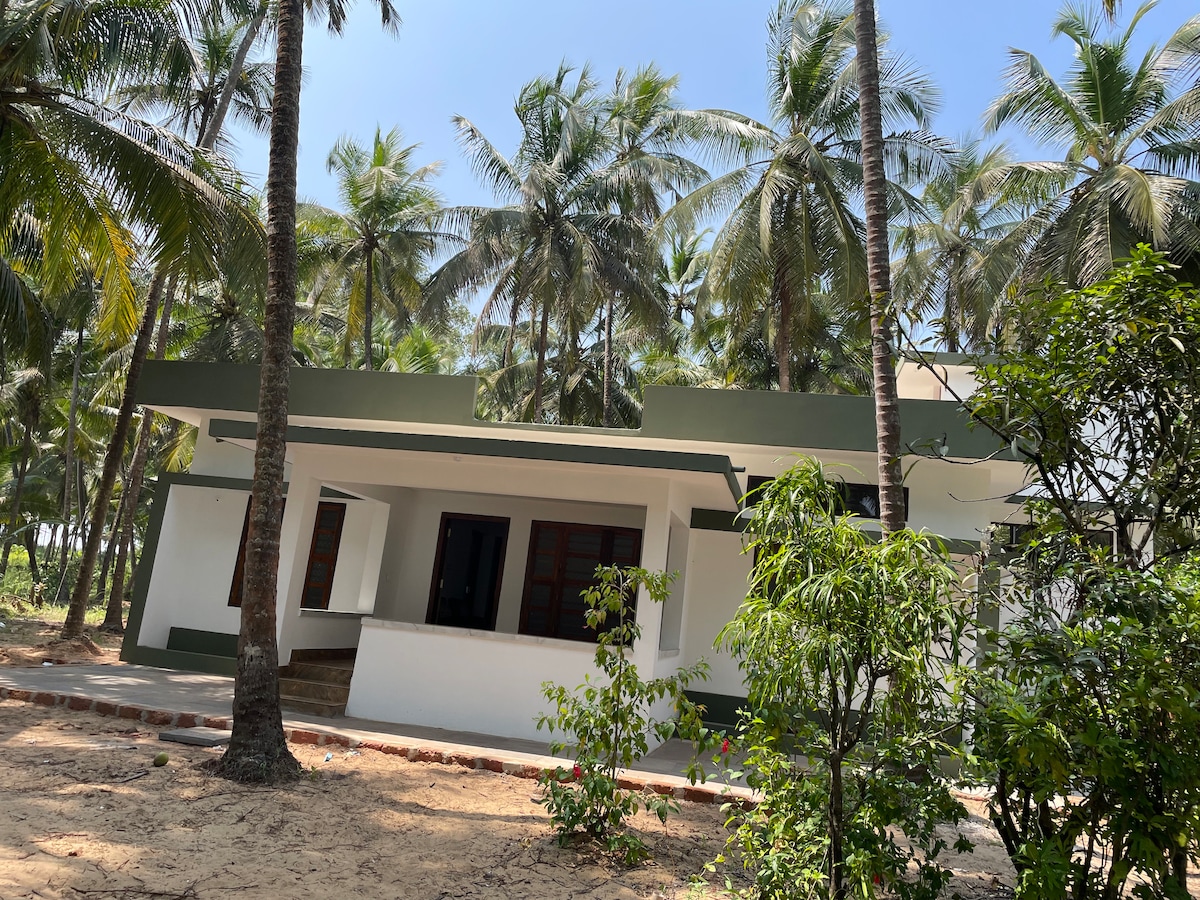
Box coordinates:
[893,140,1036,353]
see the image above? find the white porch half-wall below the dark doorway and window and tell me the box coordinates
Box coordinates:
[346,619,595,740]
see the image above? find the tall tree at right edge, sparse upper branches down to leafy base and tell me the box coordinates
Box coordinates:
[968,246,1200,900]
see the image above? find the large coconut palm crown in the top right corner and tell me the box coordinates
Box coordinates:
[985,2,1200,284]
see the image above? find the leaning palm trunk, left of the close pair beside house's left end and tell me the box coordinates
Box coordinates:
[62,270,167,638]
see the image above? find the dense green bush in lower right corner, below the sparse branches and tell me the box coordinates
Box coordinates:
[974,533,1200,900]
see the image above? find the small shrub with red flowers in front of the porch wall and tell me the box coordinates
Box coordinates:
[538,566,712,865]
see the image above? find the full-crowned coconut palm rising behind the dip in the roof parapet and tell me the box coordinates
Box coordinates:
[428,65,650,421]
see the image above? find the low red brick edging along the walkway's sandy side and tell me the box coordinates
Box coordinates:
[0,686,739,809]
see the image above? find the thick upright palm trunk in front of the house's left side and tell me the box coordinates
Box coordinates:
[217,0,305,782]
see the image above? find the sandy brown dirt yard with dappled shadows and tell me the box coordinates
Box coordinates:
[0,624,1012,900]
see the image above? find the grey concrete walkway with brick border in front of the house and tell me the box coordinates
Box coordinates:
[0,665,750,803]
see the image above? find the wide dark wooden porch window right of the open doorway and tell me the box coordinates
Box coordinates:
[521,522,642,641]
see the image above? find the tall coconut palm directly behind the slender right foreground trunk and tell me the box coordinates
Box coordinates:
[668,0,941,390]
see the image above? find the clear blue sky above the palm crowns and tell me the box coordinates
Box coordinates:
[229,0,1198,205]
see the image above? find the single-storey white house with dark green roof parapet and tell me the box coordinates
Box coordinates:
[122,362,1024,738]
